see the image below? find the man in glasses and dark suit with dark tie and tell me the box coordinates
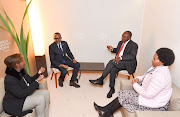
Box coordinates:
[49,32,80,88]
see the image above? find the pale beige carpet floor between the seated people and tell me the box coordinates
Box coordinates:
[47,72,128,117]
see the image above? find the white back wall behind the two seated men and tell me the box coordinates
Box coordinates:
[28,0,145,73]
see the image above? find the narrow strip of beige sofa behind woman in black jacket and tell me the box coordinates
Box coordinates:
[0,78,5,113]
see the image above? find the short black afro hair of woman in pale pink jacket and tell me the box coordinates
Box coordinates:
[156,48,175,66]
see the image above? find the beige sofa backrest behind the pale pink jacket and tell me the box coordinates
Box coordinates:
[168,84,180,111]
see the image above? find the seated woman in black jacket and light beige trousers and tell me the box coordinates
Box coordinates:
[3,54,49,117]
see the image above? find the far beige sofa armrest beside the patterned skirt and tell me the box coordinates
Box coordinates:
[120,79,133,90]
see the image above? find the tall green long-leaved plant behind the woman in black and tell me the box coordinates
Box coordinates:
[0,0,32,74]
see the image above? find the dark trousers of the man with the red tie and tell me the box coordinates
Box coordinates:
[100,60,126,87]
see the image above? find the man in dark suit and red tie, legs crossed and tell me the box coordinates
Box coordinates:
[89,31,138,98]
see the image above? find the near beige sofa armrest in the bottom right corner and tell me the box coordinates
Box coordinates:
[135,111,180,117]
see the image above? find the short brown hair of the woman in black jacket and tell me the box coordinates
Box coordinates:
[4,53,23,68]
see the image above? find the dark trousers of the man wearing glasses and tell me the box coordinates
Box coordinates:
[58,60,80,81]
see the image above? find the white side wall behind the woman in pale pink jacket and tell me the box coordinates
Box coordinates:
[137,0,180,87]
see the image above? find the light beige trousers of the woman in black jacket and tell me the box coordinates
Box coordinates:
[23,90,49,117]
